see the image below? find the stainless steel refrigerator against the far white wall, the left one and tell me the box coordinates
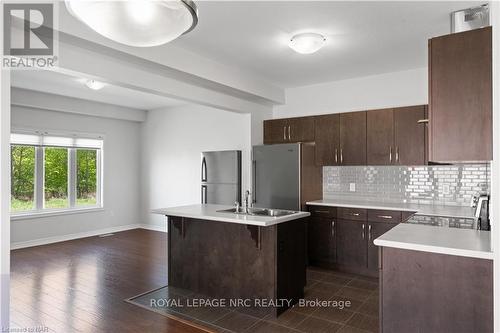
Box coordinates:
[201,150,241,205]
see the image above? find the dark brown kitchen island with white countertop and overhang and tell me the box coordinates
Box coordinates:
[153,204,310,316]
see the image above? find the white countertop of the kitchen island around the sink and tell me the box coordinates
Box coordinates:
[152,204,311,227]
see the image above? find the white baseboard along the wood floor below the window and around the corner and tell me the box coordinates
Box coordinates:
[10,224,166,250]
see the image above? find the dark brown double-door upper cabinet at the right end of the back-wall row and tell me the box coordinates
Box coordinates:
[367,105,427,165]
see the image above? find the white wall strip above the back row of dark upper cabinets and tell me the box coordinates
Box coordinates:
[273,68,428,118]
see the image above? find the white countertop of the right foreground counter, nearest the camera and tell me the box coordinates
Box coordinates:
[373,223,493,259]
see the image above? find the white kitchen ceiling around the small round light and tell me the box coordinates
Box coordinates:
[170,1,484,88]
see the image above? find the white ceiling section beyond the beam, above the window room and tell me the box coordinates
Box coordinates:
[11,70,185,110]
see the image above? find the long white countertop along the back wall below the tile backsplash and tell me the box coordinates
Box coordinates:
[307,198,474,218]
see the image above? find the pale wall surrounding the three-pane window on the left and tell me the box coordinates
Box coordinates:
[11,106,141,245]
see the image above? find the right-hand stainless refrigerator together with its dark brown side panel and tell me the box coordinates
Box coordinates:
[252,143,323,210]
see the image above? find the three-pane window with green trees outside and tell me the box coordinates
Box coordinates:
[11,133,103,215]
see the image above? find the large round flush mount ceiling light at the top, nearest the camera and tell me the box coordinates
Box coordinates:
[65,0,198,47]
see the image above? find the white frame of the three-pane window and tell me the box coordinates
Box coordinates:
[9,130,104,220]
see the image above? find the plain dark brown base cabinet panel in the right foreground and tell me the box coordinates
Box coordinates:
[380,247,493,333]
